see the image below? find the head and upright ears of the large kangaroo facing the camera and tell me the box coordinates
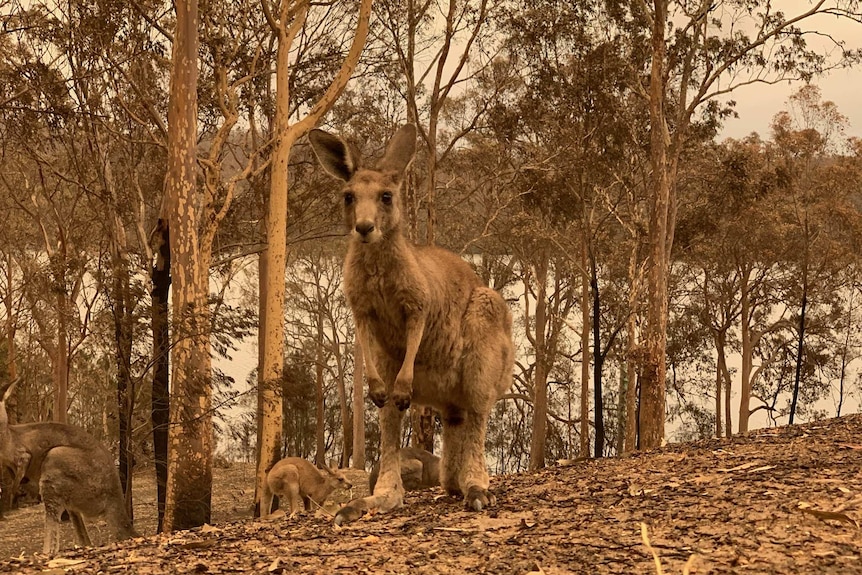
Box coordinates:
[308,124,416,243]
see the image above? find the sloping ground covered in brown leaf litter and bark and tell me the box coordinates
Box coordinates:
[0,415,862,575]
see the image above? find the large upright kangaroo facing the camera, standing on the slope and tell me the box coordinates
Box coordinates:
[309,124,514,525]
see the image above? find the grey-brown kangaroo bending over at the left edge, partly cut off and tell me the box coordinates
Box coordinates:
[0,376,137,555]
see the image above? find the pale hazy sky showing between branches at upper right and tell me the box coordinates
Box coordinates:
[719,6,862,143]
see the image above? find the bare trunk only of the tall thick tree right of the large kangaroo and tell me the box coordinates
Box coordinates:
[640,0,671,449]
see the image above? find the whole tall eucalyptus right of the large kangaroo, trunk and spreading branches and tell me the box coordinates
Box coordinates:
[608,0,862,448]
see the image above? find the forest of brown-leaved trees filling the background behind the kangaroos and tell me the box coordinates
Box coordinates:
[0,0,862,528]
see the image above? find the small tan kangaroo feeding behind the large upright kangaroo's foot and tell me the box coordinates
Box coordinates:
[260,457,353,517]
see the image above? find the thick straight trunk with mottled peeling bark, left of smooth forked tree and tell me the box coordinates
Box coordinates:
[164,0,213,531]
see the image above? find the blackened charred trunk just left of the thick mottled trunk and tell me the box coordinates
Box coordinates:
[150,218,171,532]
